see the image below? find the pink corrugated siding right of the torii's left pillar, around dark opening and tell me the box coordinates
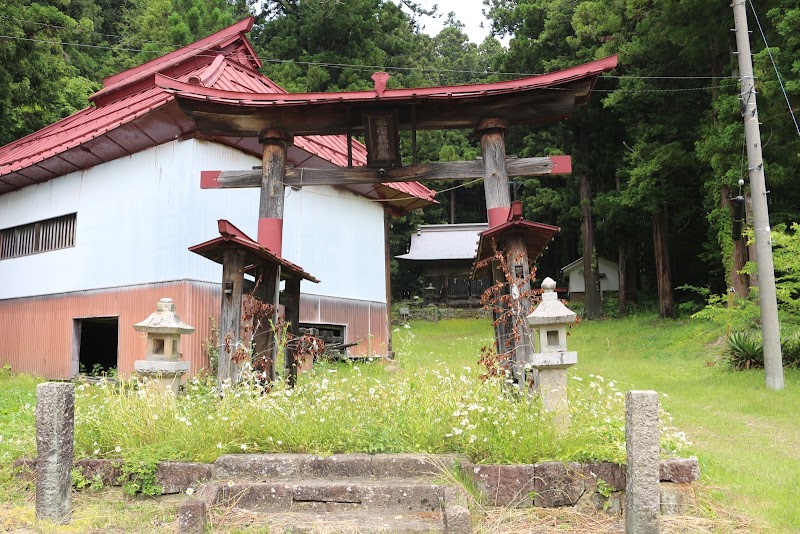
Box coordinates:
[300,295,387,356]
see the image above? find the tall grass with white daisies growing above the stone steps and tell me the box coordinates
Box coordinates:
[64,362,681,472]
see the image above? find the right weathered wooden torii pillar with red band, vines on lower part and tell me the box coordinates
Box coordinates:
[475,119,533,378]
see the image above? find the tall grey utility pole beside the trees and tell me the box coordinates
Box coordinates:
[731,0,783,389]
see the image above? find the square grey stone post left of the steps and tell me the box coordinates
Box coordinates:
[36,382,75,523]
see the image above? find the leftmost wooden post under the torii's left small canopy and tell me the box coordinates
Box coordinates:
[217,250,246,387]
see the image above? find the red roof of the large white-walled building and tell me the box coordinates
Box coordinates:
[0,19,435,211]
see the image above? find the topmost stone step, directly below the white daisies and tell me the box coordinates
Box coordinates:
[214,454,464,481]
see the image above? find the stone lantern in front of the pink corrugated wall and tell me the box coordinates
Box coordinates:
[133,298,194,394]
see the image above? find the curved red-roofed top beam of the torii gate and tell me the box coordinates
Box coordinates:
[156,56,617,136]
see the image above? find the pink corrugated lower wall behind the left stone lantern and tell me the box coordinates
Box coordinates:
[0,282,219,378]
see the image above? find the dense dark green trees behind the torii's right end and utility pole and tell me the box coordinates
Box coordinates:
[490,0,800,318]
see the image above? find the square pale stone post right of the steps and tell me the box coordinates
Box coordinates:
[625,391,661,534]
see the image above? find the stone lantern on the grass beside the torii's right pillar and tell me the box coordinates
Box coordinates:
[526,278,578,426]
